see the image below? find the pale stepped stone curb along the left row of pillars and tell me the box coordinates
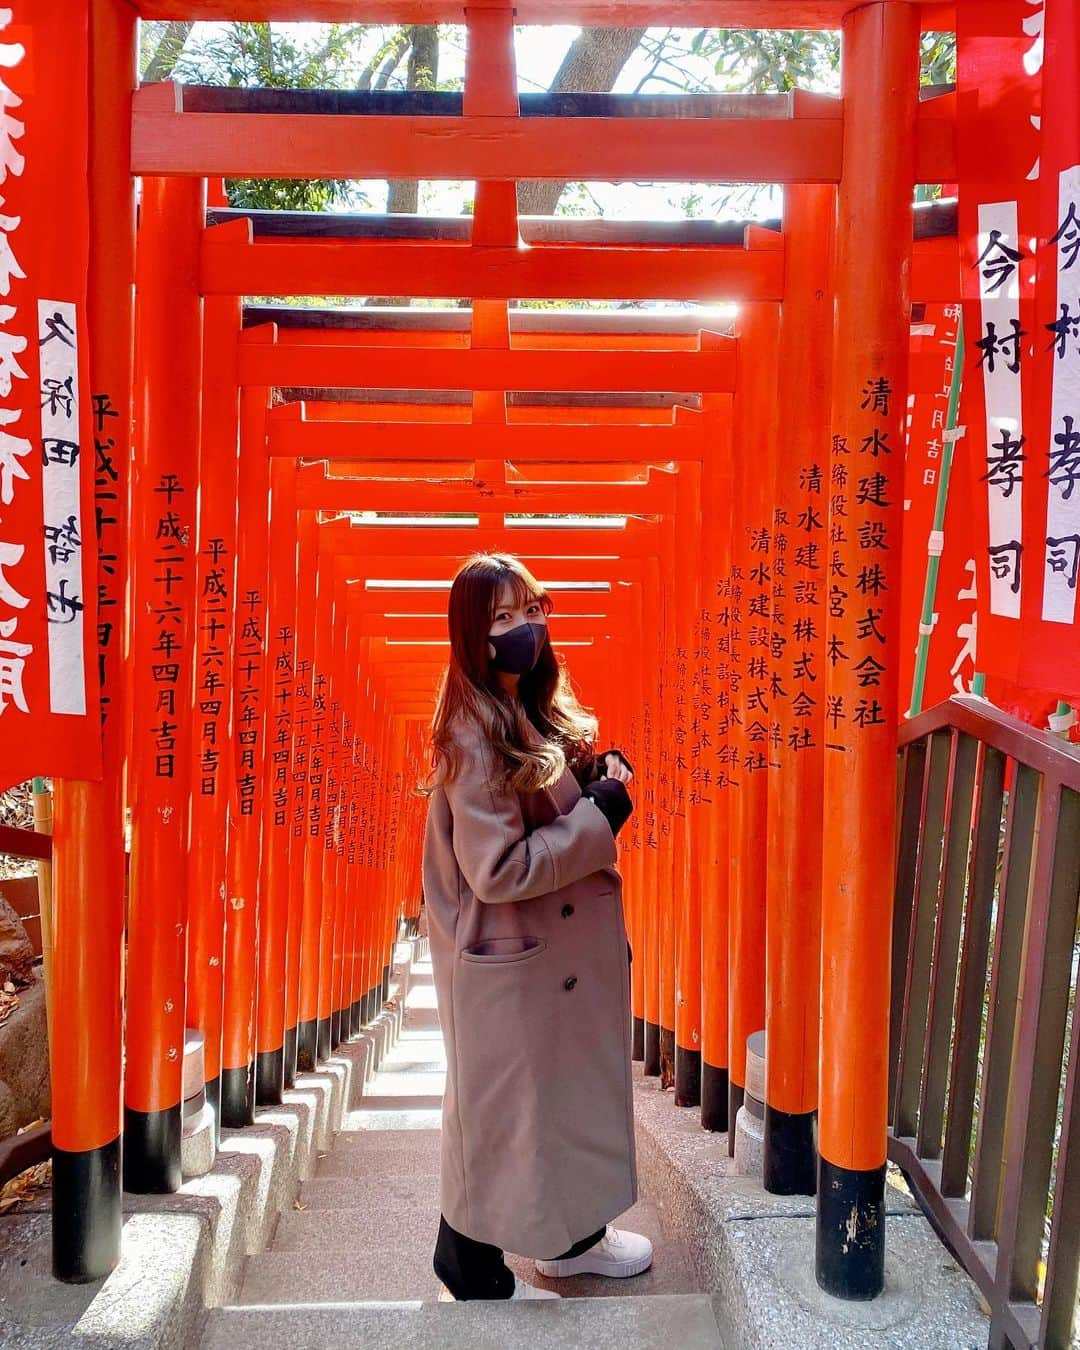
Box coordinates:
[0,940,417,1350]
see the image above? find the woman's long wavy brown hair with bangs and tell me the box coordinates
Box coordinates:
[420,554,597,795]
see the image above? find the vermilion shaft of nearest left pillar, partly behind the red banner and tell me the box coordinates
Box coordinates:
[48,3,136,1166]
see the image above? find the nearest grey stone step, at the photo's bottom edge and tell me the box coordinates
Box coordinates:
[201,1295,724,1350]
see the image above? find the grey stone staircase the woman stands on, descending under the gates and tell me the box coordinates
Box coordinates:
[203,961,722,1350]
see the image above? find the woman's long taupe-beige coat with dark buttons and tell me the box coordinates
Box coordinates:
[424,728,637,1258]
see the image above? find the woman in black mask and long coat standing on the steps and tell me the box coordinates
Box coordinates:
[424,554,652,1300]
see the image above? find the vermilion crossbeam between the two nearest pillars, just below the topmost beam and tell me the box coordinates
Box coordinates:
[131,103,842,182]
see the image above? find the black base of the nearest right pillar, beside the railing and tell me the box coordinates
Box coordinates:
[815,1158,886,1303]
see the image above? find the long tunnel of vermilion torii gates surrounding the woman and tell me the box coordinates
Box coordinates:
[1,0,1080,1317]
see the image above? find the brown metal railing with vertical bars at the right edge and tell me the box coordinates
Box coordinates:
[888,698,1080,1350]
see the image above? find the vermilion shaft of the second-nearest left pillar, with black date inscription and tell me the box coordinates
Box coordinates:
[124,180,204,1134]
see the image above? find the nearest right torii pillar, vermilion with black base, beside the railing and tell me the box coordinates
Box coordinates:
[817,0,919,1299]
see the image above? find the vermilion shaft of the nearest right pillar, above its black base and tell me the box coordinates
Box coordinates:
[819,4,917,1172]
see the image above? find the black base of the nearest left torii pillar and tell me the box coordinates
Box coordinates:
[53,1137,123,1284]
